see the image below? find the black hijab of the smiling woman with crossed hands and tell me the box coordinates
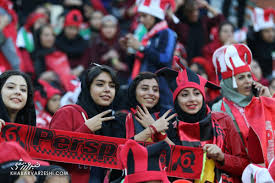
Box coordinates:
[128,72,160,114]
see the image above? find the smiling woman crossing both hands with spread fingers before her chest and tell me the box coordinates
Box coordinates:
[125,72,175,142]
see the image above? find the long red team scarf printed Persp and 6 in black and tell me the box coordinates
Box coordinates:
[0,123,203,179]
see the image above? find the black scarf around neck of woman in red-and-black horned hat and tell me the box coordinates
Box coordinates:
[175,100,207,123]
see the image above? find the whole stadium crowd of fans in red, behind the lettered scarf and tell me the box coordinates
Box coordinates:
[0,0,275,183]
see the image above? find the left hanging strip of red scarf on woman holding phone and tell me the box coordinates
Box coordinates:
[222,97,249,147]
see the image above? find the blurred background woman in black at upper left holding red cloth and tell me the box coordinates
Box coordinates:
[31,25,76,91]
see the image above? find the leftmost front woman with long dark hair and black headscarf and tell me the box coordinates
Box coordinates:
[0,70,36,129]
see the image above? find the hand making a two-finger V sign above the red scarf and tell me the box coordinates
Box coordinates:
[85,109,115,132]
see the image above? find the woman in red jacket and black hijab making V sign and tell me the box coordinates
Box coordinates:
[50,65,121,183]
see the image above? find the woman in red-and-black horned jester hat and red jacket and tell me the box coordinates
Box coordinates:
[157,56,249,182]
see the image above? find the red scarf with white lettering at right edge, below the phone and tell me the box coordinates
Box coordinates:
[245,97,275,167]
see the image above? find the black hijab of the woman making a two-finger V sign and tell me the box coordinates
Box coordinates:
[77,65,119,136]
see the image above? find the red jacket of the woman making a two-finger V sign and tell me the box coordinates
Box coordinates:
[50,104,92,183]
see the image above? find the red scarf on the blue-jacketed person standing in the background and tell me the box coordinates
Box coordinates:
[131,21,168,79]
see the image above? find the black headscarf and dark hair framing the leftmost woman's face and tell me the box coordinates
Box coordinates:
[0,70,36,126]
